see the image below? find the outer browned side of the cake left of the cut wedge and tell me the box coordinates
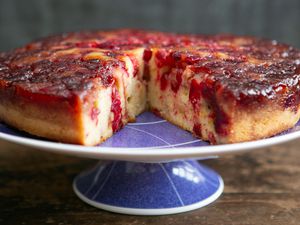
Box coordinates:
[0,81,84,144]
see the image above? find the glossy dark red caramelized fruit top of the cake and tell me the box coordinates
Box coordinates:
[0,30,300,107]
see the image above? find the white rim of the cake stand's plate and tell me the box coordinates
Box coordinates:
[0,125,300,162]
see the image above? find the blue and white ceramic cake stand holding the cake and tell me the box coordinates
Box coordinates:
[0,112,300,215]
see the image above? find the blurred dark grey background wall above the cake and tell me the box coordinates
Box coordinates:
[0,0,300,51]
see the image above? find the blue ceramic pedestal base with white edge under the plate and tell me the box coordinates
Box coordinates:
[73,160,224,215]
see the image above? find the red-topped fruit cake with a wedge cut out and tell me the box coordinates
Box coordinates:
[0,29,300,145]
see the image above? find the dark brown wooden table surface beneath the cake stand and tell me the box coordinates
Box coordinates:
[0,141,300,225]
